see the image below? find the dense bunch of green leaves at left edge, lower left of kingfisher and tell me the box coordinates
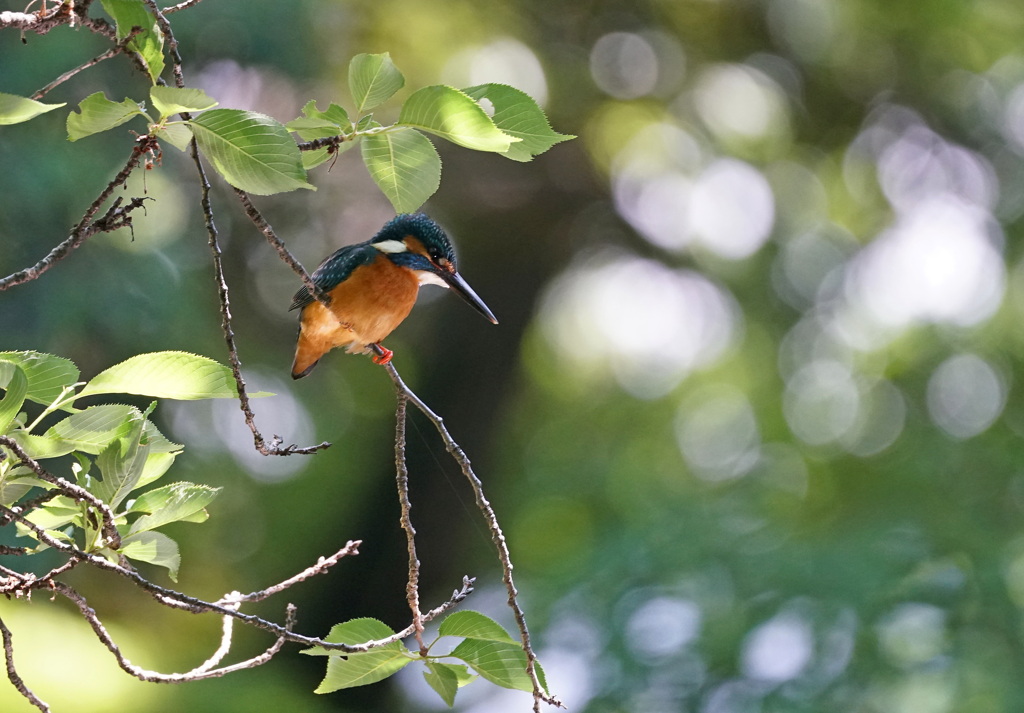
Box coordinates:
[0,351,252,579]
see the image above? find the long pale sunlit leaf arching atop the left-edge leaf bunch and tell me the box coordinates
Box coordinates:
[79,351,266,401]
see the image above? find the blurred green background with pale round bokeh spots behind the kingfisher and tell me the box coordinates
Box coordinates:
[0,0,1024,713]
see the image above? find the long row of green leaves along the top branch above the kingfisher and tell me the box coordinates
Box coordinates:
[0,0,572,212]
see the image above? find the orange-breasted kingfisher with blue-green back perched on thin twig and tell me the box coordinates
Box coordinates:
[290,213,498,379]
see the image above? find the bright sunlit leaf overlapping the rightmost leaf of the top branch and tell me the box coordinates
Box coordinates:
[397,84,519,154]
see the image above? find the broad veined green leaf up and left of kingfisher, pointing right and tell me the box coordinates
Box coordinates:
[189,109,315,196]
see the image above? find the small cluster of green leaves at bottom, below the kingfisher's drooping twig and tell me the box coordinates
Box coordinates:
[303,611,547,706]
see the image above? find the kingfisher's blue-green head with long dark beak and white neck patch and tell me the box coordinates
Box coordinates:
[370,213,498,325]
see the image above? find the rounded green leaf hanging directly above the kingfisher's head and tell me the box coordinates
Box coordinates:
[362,131,441,213]
